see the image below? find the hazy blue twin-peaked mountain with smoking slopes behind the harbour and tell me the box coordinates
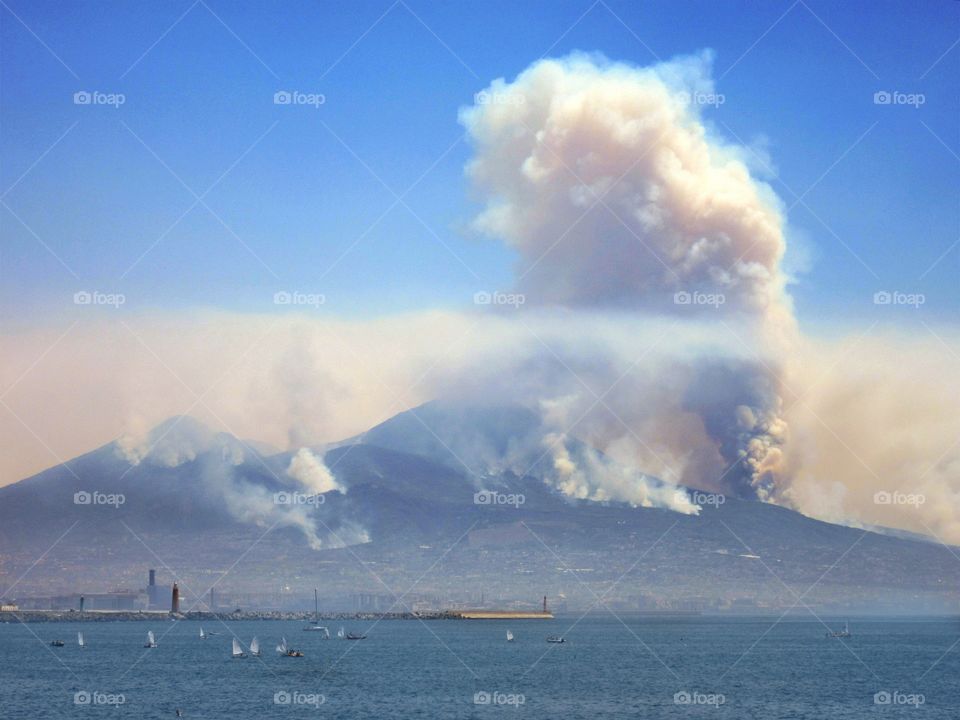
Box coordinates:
[0,403,960,612]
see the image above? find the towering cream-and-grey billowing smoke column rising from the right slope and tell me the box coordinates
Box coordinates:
[461,54,795,498]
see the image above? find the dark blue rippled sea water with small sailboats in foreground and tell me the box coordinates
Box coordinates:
[0,615,960,720]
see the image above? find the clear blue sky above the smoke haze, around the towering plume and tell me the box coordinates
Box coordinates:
[0,0,960,326]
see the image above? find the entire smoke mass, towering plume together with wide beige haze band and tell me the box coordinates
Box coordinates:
[0,55,960,543]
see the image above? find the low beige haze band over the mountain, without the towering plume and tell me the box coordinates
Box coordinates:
[0,309,960,543]
